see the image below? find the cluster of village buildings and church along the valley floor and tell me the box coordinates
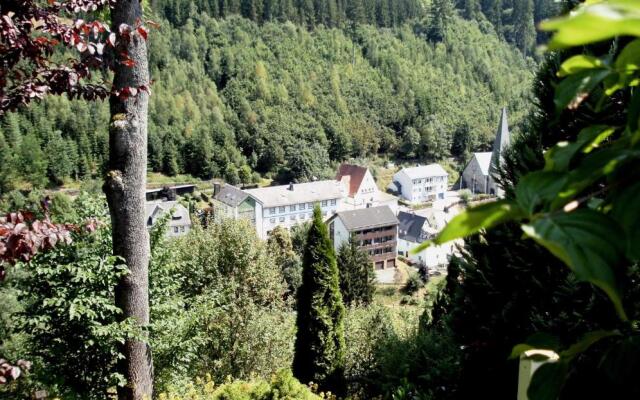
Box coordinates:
[146,108,510,283]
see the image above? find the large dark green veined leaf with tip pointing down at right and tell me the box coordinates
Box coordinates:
[522,209,627,320]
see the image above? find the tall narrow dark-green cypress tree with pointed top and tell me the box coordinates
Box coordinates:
[293,206,345,394]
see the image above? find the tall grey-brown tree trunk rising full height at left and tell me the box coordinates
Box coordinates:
[104,0,153,400]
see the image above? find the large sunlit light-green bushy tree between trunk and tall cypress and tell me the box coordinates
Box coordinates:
[150,220,295,388]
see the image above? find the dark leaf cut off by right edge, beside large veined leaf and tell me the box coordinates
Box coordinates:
[610,182,640,261]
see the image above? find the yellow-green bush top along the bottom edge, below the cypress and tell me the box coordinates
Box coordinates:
[159,370,325,400]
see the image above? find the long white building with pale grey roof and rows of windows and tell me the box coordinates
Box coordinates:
[244,180,346,240]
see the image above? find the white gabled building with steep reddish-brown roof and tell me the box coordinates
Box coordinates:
[336,163,398,214]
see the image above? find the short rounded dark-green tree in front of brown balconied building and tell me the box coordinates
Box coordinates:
[337,237,376,306]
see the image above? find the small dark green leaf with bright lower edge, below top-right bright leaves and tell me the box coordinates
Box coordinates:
[553,70,610,111]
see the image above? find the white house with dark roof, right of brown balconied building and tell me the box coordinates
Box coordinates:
[398,210,456,269]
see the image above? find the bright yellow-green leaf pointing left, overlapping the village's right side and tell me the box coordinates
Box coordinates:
[412,200,524,253]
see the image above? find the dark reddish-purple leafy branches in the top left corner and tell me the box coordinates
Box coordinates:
[0,0,154,115]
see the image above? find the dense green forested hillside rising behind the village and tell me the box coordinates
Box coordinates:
[0,0,535,191]
